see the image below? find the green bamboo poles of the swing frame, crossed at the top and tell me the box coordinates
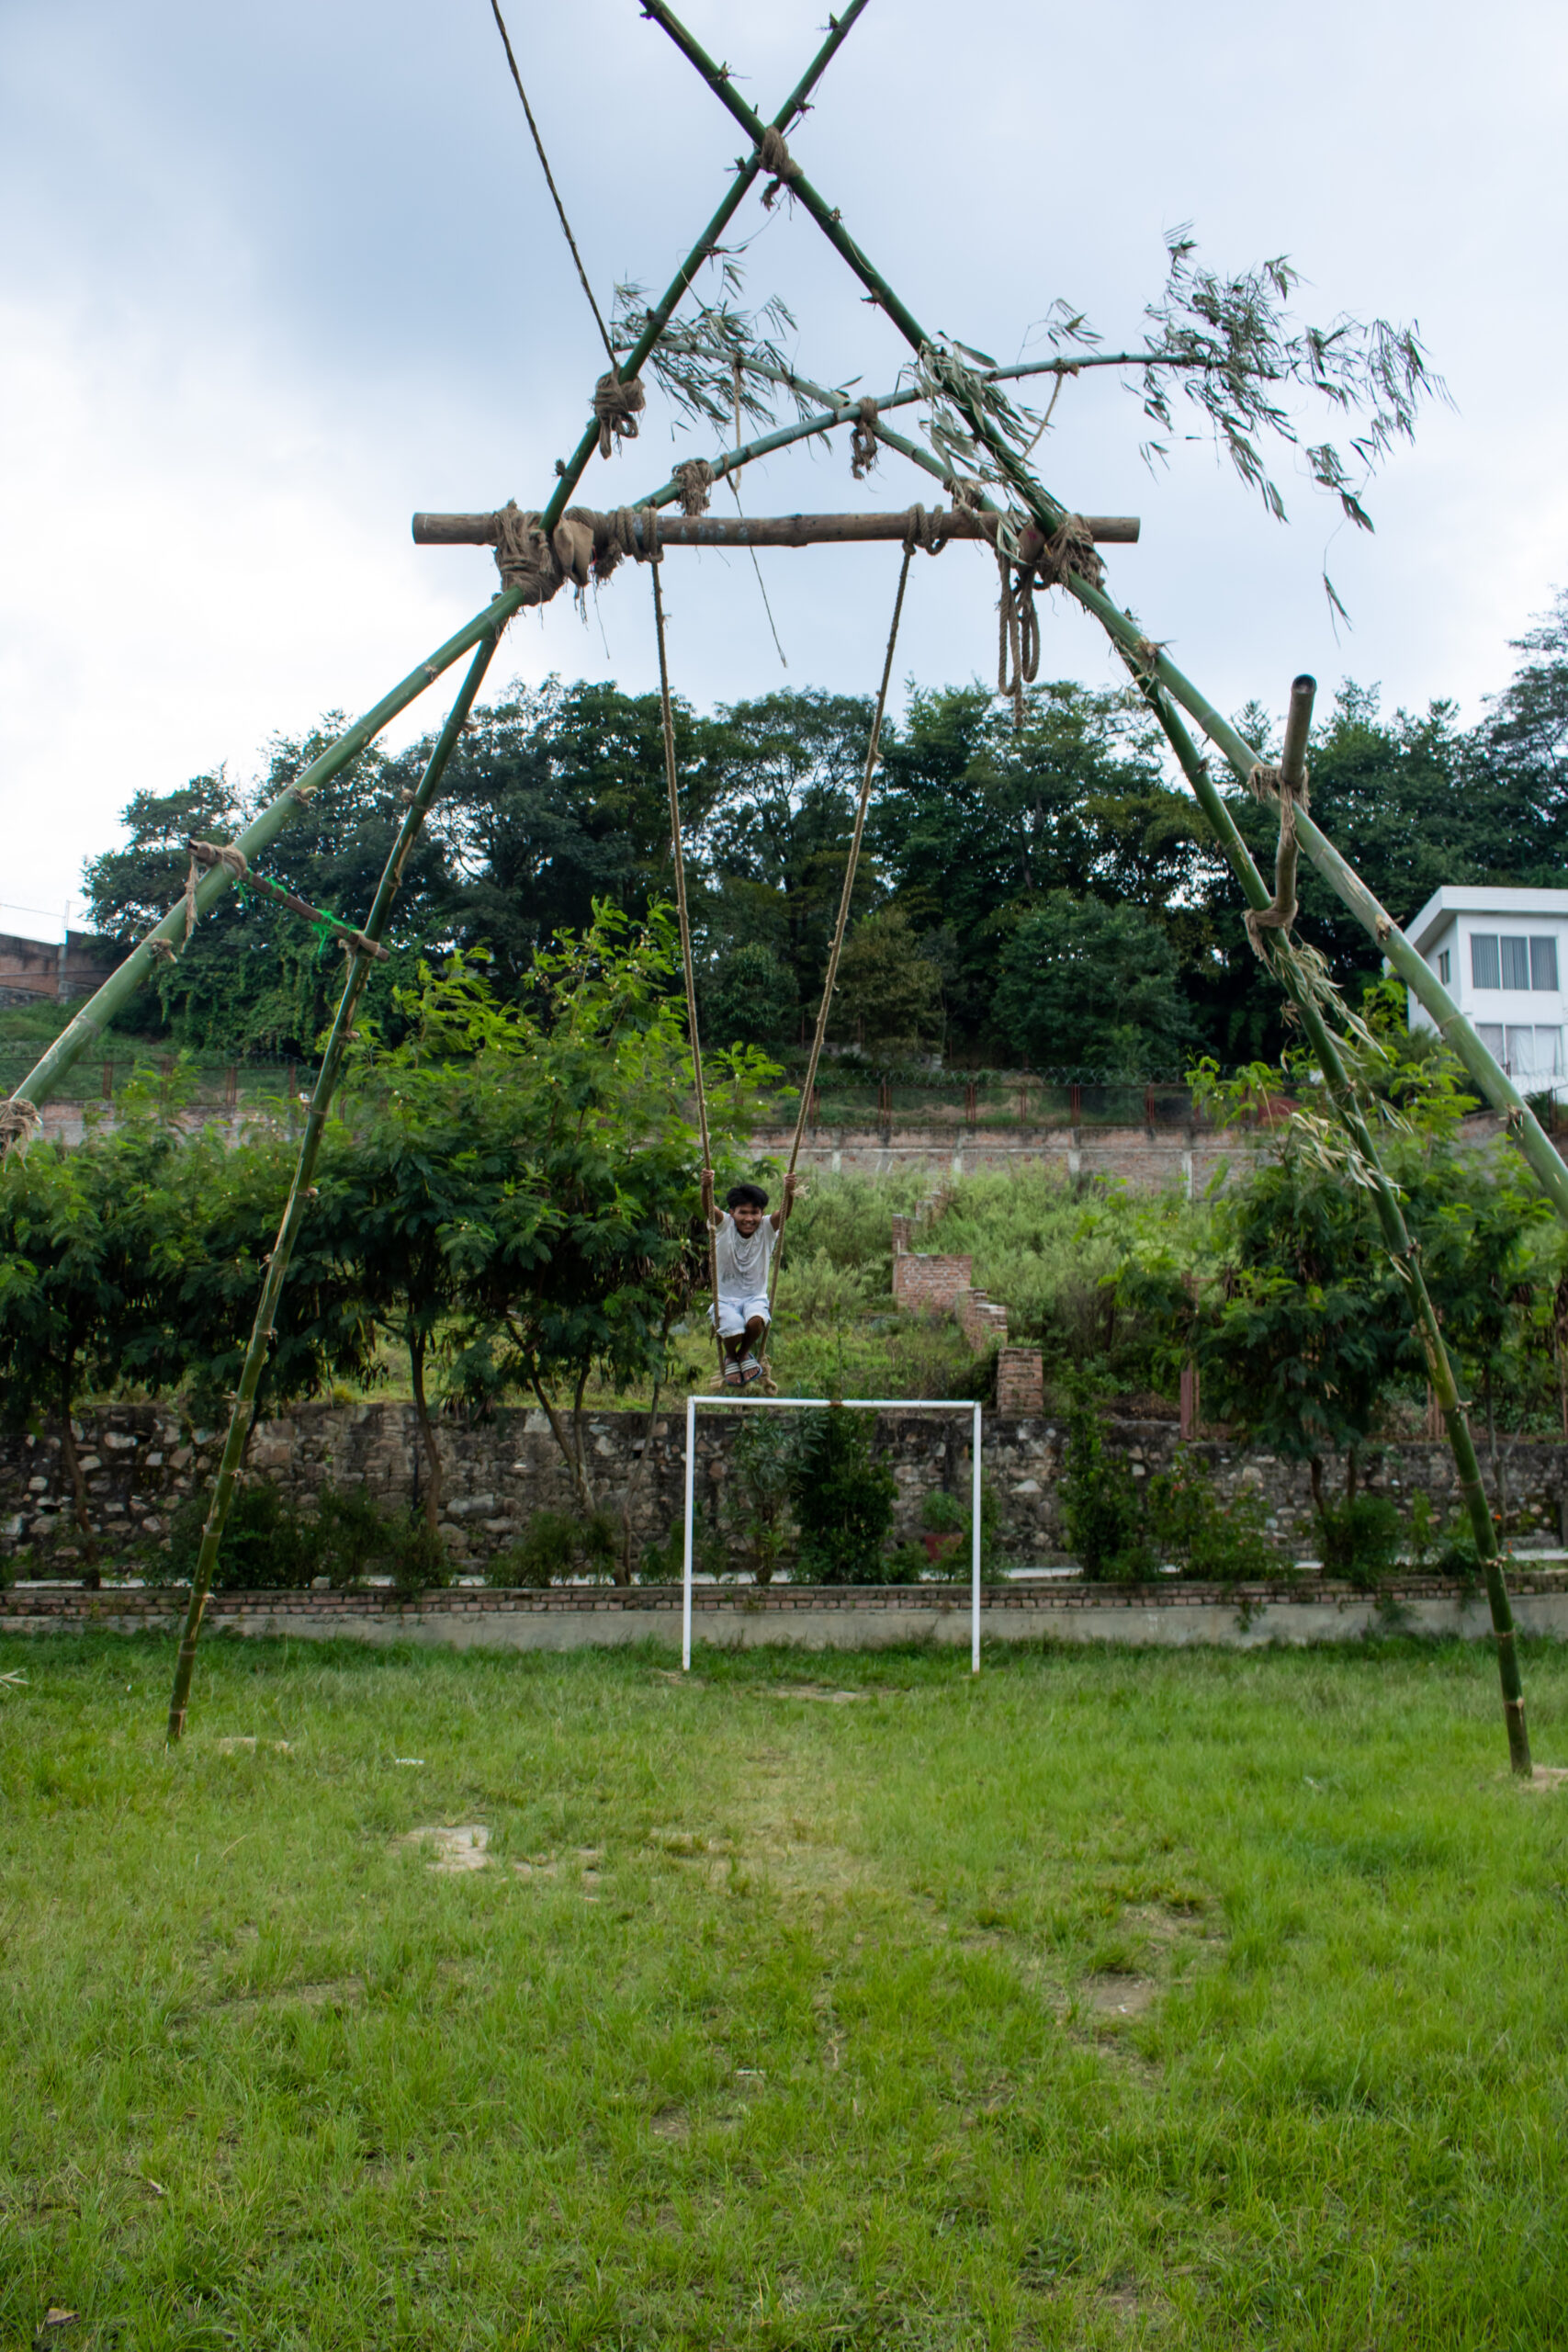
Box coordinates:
[9,0,1568,1773]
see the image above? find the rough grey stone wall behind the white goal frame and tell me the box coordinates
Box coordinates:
[0,1404,1568,1574]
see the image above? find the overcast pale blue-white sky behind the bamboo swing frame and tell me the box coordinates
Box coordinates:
[0,0,1568,936]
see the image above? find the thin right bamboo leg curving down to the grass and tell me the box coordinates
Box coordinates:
[1140,680,1533,1778]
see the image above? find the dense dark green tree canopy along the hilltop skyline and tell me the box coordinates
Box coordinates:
[87,597,1568,1063]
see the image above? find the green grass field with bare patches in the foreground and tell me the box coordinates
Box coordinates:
[0,1637,1568,2352]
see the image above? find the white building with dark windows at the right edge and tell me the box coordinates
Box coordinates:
[1405,885,1568,1093]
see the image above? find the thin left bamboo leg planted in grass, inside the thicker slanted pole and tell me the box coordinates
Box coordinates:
[167,626,501,1746]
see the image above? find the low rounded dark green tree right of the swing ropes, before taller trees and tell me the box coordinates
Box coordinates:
[992,891,1192,1077]
